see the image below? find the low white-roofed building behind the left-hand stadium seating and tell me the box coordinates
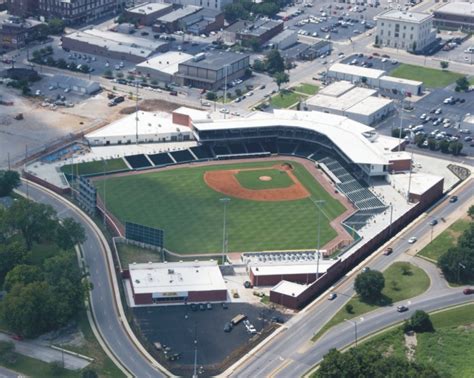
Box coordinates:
[85,111,196,146]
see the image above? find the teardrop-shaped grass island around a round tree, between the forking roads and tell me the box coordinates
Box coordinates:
[312,262,430,341]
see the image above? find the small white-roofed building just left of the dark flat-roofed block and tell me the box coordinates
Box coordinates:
[137,51,193,86]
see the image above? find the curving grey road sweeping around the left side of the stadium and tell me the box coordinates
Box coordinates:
[19,183,166,377]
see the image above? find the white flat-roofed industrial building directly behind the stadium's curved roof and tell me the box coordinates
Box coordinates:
[305,81,394,125]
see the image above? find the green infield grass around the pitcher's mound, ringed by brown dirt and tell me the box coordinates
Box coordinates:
[235,169,293,190]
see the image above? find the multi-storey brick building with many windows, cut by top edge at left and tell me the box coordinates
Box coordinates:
[38,0,125,25]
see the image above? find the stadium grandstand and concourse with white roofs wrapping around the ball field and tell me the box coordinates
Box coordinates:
[27,108,451,309]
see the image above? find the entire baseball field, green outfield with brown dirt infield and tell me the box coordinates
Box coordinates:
[95,160,345,254]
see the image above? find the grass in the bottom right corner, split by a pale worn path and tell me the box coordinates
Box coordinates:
[360,304,474,378]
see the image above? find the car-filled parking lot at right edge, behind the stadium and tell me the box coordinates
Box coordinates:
[377,89,474,157]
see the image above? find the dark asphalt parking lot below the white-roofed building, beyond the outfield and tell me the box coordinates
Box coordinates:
[133,303,285,376]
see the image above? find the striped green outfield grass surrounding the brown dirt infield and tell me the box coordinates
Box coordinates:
[96,161,344,254]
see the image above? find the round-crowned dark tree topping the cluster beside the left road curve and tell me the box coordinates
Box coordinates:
[7,200,57,251]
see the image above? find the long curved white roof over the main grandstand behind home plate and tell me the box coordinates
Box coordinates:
[193,110,398,164]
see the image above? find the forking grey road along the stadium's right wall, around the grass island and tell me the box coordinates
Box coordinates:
[232,180,474,377]
